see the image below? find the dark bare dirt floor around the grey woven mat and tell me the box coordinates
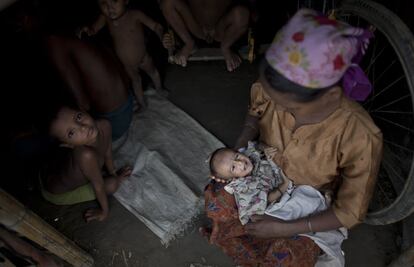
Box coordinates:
[19,59,399,267]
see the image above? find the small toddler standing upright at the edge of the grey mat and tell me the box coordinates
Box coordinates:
[79,0,166,108]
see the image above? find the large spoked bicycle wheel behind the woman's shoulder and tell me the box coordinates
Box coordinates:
[334,0,414,225]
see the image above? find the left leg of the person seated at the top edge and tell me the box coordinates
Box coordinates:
[160,0,204,67]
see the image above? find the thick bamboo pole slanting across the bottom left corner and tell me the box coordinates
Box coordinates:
[0,188,93,267]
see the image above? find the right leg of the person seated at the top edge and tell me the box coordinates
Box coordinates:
[215,6,250,71]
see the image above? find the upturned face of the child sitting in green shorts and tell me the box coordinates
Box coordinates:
[50,107,98,146]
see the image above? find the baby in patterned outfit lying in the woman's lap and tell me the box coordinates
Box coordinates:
[210,142,291,225]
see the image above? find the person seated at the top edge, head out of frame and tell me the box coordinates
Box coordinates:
[159,0,250,71]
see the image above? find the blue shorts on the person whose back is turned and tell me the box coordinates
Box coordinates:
[95,92,134,141]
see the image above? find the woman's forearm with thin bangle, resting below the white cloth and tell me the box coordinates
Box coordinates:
[246,208,342,238]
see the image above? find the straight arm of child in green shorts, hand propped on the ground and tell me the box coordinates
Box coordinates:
[75,148,109,222]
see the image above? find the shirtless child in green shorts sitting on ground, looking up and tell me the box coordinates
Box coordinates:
[41,107,132,222]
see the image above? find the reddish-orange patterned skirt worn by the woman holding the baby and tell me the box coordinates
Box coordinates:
[205,181,320,267]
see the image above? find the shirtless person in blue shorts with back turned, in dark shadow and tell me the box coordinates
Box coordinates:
[46,36,133,141]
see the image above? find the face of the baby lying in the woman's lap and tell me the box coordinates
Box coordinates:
[216,150,253,179]
